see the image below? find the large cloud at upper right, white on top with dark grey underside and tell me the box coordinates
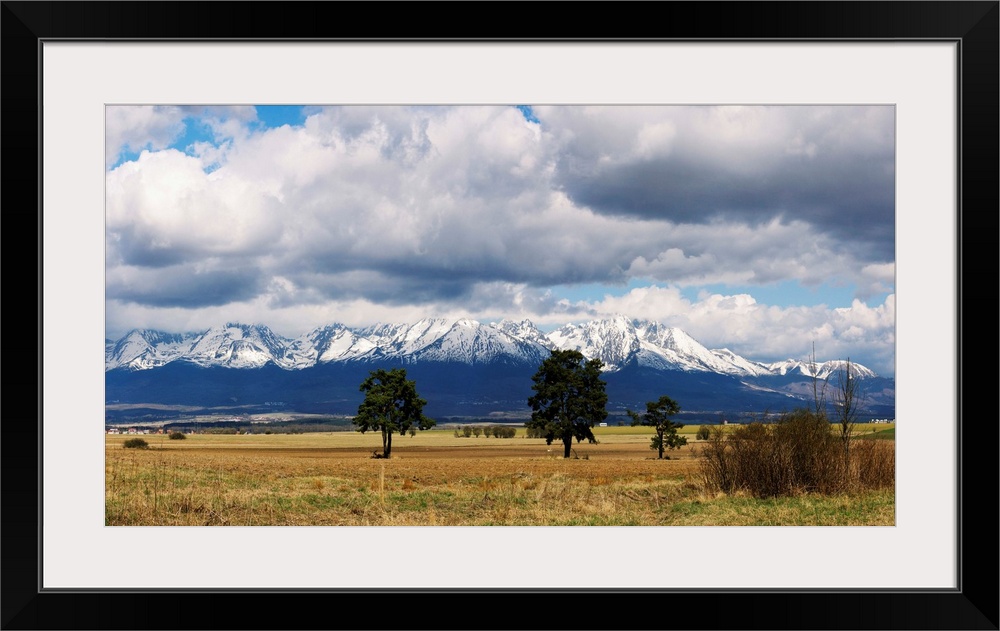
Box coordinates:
[543,107,895,261]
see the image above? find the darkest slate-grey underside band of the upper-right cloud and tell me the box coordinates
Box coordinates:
[563,151,895,260]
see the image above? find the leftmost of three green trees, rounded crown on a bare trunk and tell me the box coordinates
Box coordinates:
[352,368,434,458]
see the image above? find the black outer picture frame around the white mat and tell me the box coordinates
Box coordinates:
[0,1,1000,629]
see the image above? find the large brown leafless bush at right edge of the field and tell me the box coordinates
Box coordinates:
[701,410,896,498]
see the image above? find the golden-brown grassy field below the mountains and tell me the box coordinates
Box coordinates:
[105,425,895,526]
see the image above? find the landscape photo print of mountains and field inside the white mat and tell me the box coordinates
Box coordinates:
[103,103,896,526]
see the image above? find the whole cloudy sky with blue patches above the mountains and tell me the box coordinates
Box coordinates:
[105,104,896,376]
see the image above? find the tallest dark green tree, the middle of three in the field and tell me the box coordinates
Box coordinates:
[526,350,608,458]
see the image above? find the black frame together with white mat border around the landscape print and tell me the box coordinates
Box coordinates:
[2,2,1000,629]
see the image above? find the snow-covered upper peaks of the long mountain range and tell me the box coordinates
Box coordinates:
[105,315,877,379]
